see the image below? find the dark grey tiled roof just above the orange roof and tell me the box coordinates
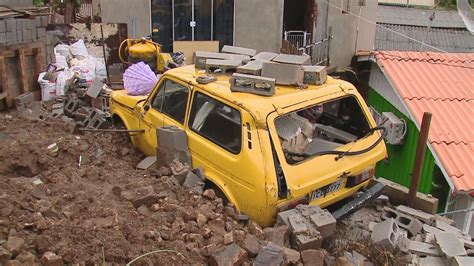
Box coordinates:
[374,23,474,53]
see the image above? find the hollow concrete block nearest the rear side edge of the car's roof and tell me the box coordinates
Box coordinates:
[229,73,275,96]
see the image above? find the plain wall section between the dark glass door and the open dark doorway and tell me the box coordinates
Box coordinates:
[234,0,283,53]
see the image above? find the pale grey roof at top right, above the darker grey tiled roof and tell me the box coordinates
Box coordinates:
[377,5,466,29]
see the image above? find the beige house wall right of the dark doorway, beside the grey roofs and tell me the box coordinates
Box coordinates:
[315,0,378,67]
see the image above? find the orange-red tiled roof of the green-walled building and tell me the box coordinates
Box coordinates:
[376,51,474,192]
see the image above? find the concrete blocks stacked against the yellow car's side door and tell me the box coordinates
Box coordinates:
[156,126,191,167]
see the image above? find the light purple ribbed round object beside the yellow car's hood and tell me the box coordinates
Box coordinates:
[123,62,158,96]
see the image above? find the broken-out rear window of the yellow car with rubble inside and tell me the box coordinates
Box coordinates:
[275,96,370,164]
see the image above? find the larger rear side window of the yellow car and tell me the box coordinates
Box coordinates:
[189,92,242,154]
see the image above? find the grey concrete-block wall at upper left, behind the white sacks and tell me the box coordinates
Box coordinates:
[0,16,53,63]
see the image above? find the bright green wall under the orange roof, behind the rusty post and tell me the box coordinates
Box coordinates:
[367,89,435,194]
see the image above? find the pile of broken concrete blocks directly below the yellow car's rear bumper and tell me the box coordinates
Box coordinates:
[276,205,336,251]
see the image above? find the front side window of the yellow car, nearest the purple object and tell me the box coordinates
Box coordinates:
[156,79,189,124]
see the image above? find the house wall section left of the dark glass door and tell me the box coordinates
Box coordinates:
[100,0,151,38]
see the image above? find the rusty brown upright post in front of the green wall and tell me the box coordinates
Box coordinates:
[407,112,432,207]
